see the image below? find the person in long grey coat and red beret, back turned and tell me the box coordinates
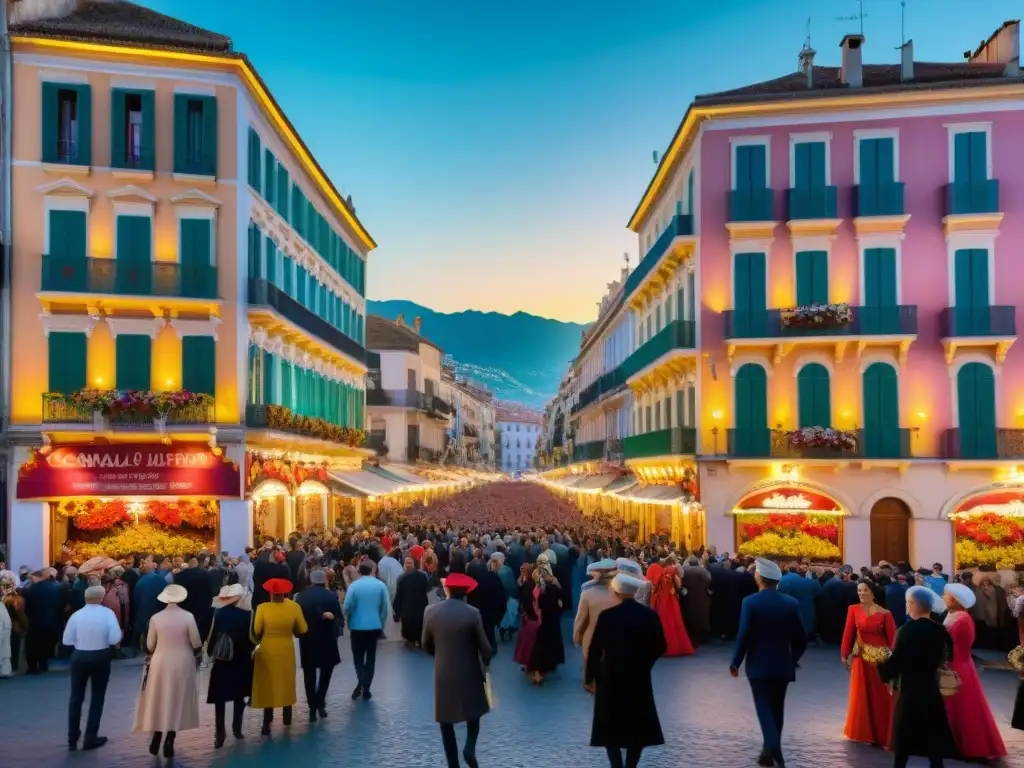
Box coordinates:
[423,573,492,768]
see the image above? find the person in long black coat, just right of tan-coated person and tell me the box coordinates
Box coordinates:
[584,573,668,768]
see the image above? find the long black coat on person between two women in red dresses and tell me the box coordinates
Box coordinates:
[879,618,954,758]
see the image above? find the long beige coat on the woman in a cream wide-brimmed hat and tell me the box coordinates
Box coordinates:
[132,603,203,732]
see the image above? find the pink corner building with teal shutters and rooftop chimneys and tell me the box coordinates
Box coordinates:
[626,22,1024,568]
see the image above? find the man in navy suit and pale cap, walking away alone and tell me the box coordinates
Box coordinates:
[729,557,807,767]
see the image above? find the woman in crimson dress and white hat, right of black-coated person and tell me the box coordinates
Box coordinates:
[943,584,1007,760]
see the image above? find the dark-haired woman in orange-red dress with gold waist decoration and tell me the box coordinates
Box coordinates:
[840,581,896,748]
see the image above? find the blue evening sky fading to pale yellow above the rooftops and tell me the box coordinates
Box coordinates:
[142,0,1020,322]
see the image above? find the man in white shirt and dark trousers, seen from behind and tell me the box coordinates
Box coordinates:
[63,587,121,752]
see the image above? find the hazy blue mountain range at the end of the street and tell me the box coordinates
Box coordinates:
[367,299,586,408]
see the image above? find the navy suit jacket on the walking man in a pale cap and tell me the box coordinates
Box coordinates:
[730,589,807,682]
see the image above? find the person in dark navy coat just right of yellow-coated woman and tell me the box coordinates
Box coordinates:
[295,570,342,723]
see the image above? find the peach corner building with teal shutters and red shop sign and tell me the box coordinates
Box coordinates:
[6,0,375,566]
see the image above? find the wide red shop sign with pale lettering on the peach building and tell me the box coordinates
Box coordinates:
[17,443,242,499]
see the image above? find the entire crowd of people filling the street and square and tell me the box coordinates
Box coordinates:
[0,482,1024,766]
